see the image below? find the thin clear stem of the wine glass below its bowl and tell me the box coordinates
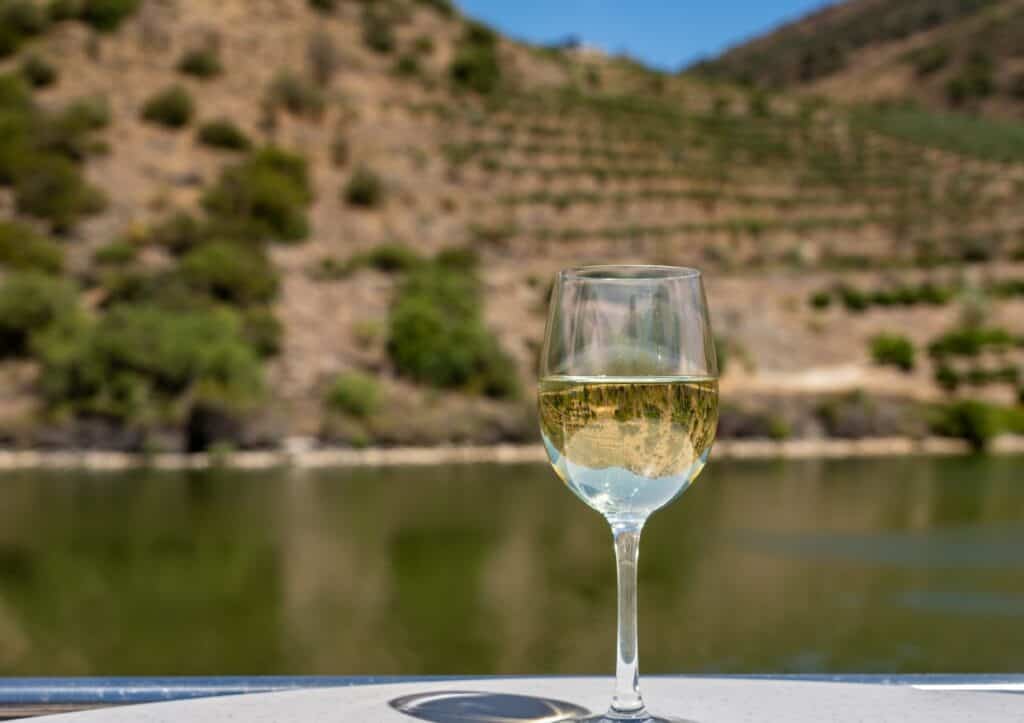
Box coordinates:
[611,521,643,716]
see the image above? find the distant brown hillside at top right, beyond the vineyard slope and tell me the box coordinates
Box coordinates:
[693,0,1024,118]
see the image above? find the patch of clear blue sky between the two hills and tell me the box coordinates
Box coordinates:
[456,0,828,70]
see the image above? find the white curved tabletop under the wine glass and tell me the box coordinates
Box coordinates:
[33,678,1024,723]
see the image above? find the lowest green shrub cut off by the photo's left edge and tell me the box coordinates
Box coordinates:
[0,271,77,356]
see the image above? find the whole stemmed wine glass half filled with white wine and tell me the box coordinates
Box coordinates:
[538,265,718,723]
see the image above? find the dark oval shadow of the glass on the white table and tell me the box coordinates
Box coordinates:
[388,690,590,723]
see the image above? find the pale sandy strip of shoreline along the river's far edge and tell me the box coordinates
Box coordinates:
[0,435,1024,471]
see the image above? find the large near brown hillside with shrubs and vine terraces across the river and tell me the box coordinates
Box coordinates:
[0,0,1024,450]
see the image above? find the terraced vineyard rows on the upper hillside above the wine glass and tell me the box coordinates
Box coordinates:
[436,92,1021,268]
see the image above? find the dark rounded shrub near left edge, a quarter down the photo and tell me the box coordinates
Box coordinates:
[14,155,106,230]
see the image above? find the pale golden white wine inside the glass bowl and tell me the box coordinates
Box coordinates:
[539,377,718,520]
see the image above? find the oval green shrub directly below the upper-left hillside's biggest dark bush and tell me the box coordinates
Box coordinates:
[178,237,278,306]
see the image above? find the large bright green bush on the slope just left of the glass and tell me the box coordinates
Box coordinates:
[388,264,518,397]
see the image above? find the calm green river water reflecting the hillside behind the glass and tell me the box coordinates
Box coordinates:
[0,455,1024,675]
